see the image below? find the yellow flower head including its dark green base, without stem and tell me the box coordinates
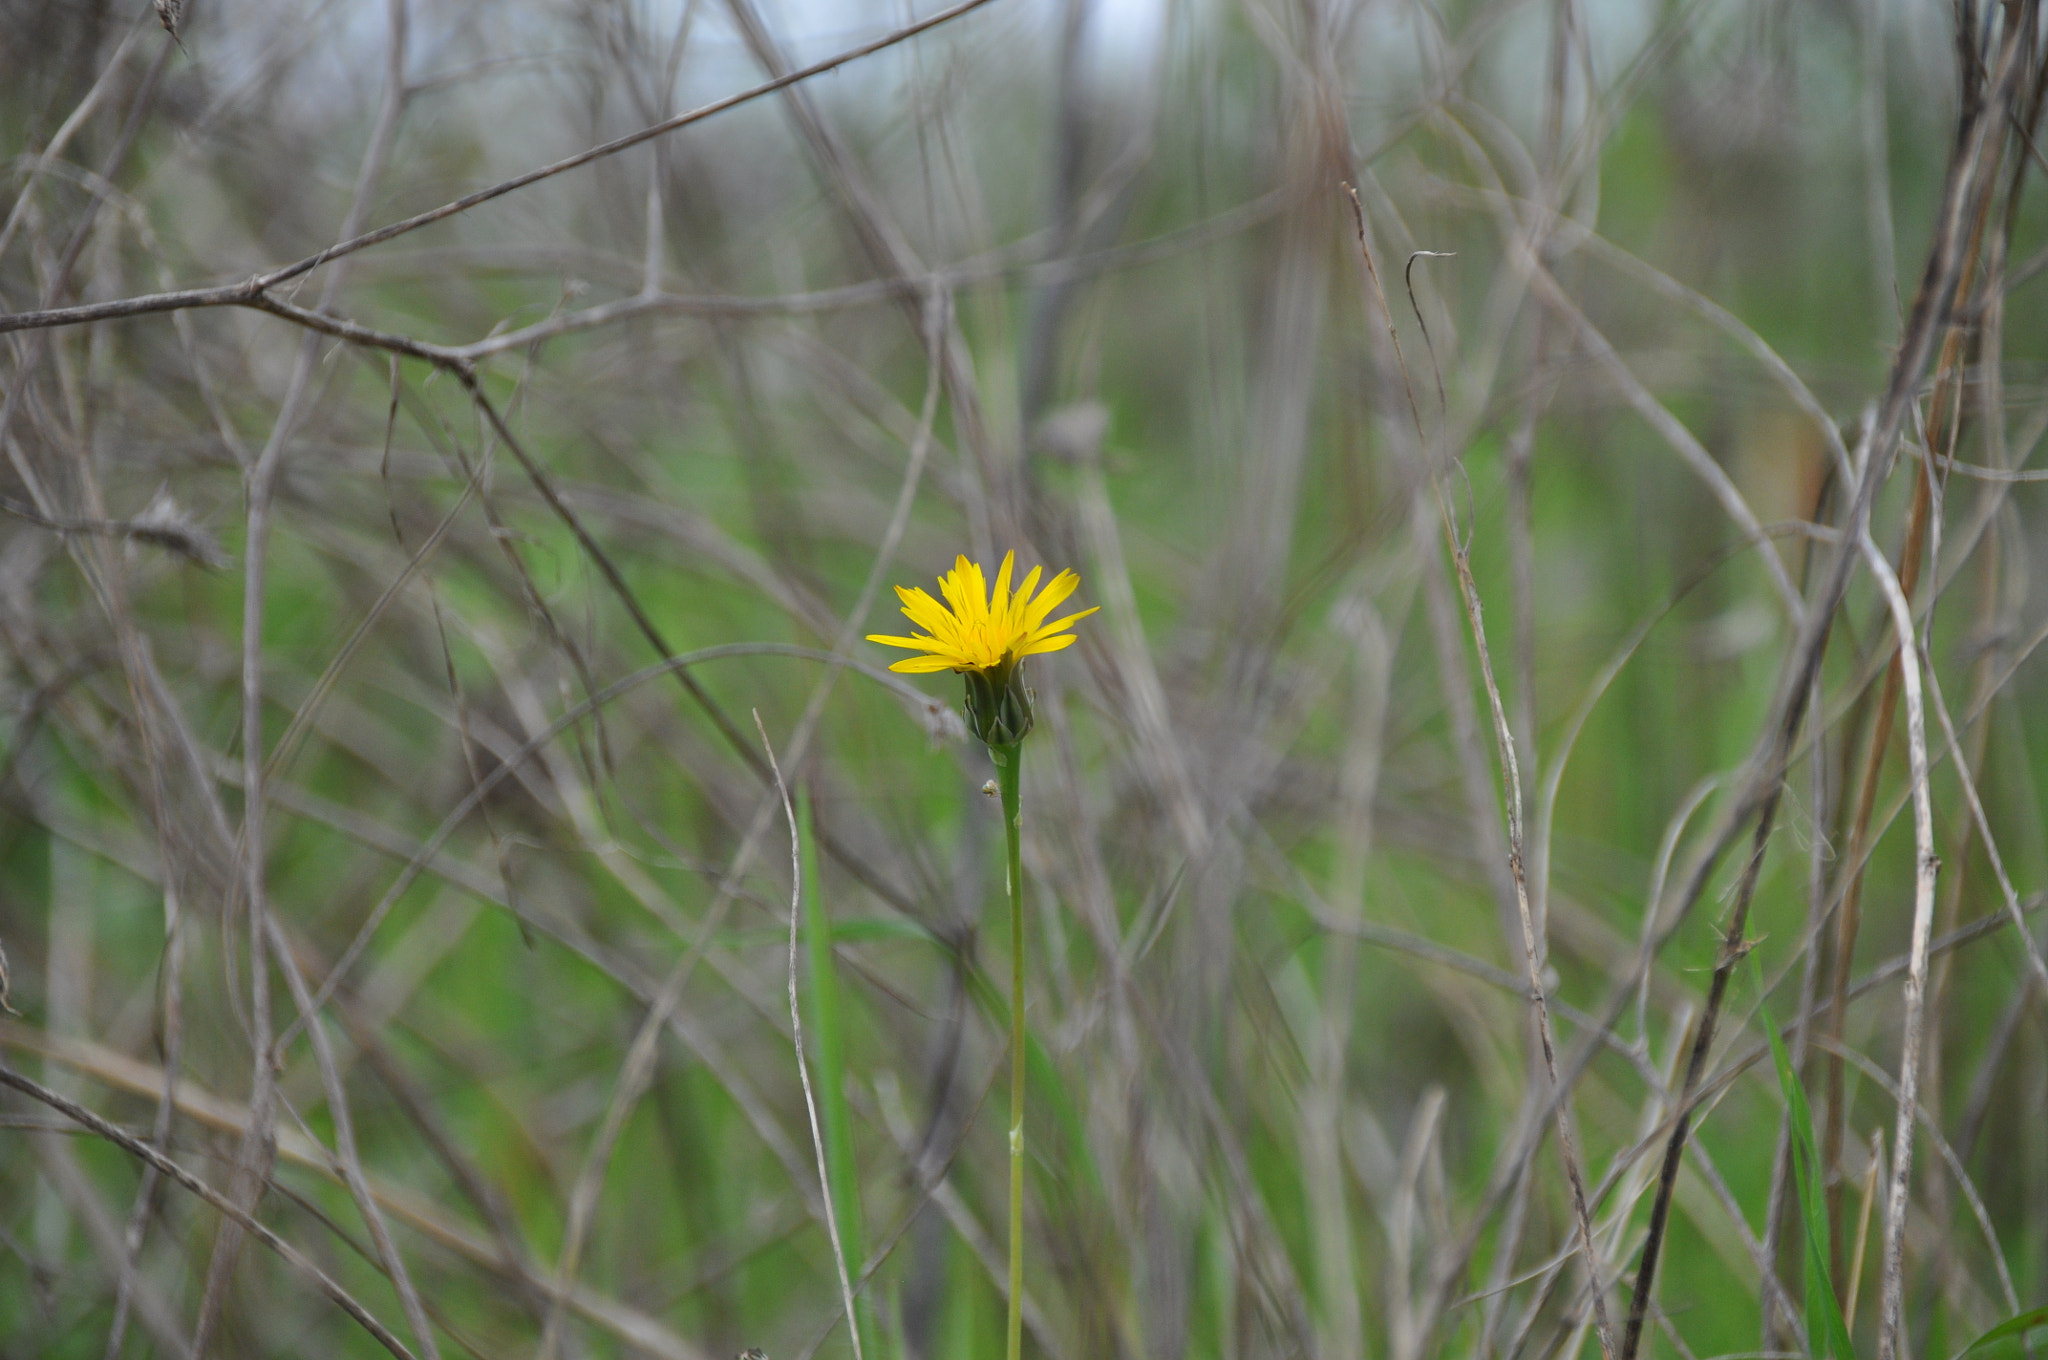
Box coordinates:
[868,553,1096,748]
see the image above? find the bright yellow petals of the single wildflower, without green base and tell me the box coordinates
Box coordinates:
[868,553,1096,678]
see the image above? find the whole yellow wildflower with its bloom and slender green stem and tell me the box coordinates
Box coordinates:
[868,553,1096,1360]
